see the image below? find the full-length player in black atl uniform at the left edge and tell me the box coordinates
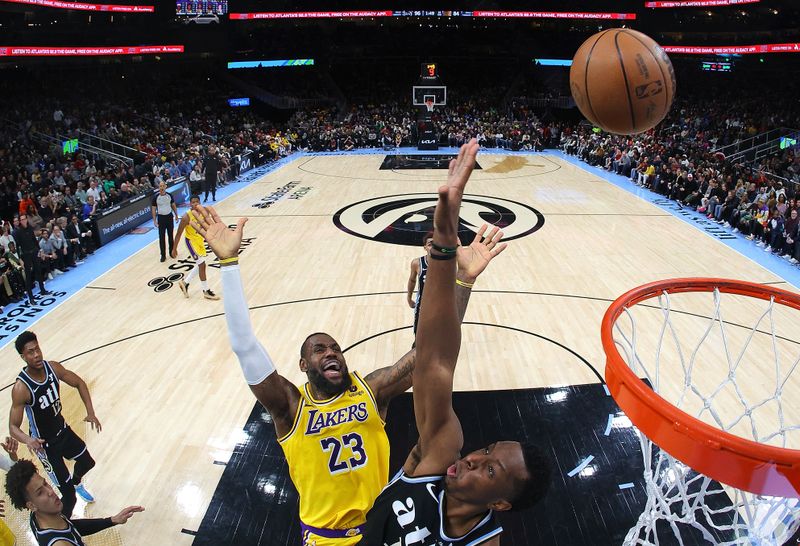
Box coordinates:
[8,332,101,517]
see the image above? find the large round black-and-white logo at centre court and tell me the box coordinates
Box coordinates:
[333,193,544,246]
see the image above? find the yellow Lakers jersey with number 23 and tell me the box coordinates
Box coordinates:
[278,372,389,529]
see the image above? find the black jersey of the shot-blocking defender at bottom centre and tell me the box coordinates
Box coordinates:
[359,472,503,546]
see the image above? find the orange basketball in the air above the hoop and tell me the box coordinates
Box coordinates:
[569,28,675,135]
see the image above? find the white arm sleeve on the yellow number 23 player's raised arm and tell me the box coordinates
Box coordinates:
[222,265,275,385]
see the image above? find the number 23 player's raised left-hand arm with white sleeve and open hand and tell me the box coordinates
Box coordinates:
[190,205,300,437]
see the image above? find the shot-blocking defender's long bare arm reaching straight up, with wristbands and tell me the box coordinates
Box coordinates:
[413,139,505,475]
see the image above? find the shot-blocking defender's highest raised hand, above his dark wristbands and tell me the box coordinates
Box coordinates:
[433,138,480,246]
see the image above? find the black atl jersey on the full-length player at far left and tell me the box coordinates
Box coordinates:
[17,360,65,440]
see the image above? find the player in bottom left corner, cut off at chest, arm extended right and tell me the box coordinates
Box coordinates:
[6,459,144,546]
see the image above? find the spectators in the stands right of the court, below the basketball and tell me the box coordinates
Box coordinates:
[559,93,800,264]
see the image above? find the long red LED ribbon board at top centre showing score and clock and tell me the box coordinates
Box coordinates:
[230,10,636,21]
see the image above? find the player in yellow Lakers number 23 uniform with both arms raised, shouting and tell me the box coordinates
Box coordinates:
[194,199,504,546]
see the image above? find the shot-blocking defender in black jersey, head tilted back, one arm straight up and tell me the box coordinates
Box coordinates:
[360,139,550,546]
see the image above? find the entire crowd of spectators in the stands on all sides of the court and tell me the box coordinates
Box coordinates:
[0,65,800,305]
